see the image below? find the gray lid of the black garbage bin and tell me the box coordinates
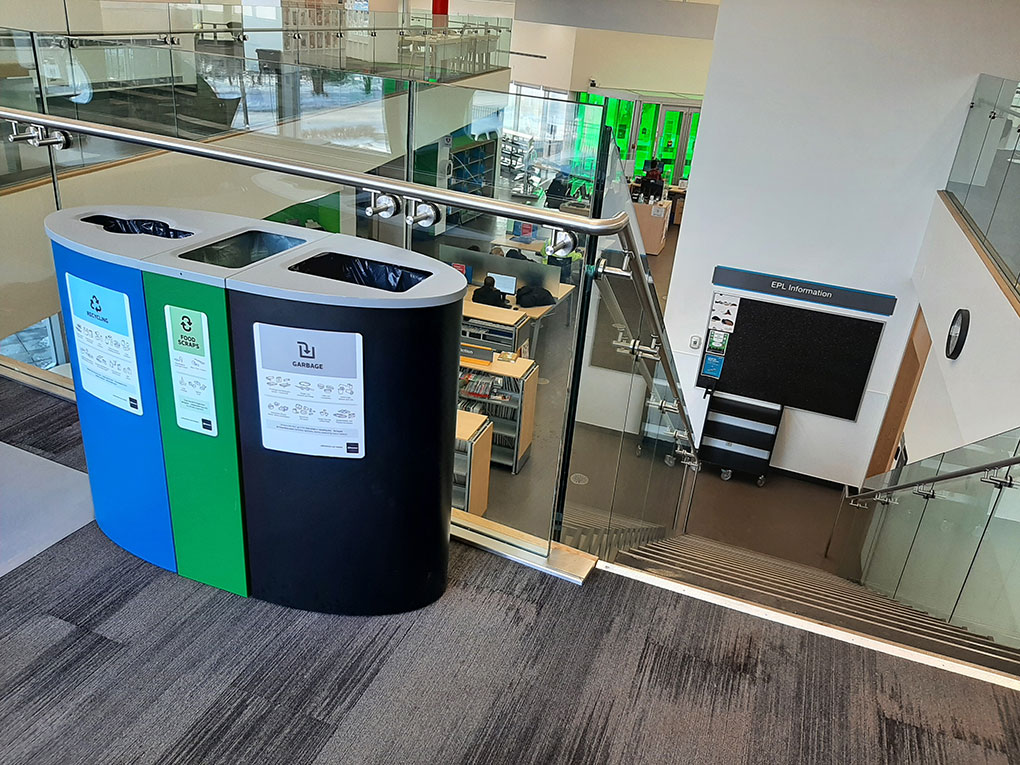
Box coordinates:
[226,234,467,308]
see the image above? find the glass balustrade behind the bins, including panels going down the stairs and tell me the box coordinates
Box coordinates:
[0,20,693,567]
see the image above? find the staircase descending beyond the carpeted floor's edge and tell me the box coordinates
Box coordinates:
[606,534,1020,675]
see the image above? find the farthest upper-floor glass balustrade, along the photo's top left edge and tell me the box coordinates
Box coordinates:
[0,0,511,82]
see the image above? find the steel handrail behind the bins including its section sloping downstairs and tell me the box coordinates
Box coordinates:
[0,100,694,448]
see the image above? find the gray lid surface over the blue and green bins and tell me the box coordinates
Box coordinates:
[44,205,326,287]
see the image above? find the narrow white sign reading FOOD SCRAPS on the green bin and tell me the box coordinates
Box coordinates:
[163,305,219,436]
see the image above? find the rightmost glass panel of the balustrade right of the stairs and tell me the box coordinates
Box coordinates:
[950,466,1020,648]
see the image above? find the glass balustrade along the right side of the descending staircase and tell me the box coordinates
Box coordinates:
[829,429,1020,646]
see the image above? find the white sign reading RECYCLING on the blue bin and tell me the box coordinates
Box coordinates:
[66,273,142,414]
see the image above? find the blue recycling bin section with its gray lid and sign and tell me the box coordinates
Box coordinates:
[45,206,225,571]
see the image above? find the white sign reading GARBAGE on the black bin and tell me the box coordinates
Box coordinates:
[254,323,365,459]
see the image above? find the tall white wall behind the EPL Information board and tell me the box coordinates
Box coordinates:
[666,0,1020,483]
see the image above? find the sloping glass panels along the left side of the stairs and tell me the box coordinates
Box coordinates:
[561,142,696,560]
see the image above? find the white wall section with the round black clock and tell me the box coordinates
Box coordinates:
[905,199,1020,460]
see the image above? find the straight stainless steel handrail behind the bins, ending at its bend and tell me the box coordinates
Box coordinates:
[0,106,629,237]
